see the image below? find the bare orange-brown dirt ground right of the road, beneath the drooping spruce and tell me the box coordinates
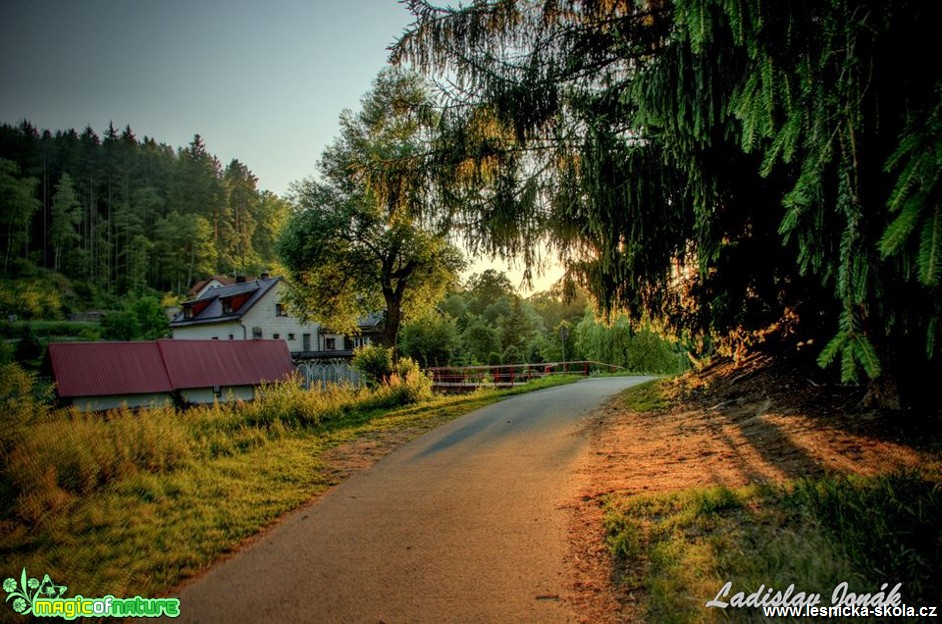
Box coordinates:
[569,356,935,623]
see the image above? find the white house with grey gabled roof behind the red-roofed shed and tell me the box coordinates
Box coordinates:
[170,275,379,359]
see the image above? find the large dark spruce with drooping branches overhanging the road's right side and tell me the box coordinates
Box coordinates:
[393,0,942,402]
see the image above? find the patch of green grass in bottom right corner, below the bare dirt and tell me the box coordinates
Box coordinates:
[606,473,942,623]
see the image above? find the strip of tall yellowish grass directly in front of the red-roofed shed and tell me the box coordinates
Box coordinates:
[0,366,431,523]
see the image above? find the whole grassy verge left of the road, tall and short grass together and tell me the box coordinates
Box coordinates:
[0,368,573,621]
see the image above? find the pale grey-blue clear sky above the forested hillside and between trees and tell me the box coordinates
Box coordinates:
[0,0,558,289]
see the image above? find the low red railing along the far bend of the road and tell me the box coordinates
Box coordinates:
[426,360,624,390]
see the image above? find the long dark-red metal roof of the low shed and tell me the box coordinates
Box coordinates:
[49,340,294,397]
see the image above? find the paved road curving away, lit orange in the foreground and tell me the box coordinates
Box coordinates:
[177,377,645,624]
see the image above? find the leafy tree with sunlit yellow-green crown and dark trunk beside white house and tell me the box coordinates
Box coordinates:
[278,70,464,347]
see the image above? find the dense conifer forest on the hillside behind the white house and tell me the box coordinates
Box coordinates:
[0,121,288,299]
